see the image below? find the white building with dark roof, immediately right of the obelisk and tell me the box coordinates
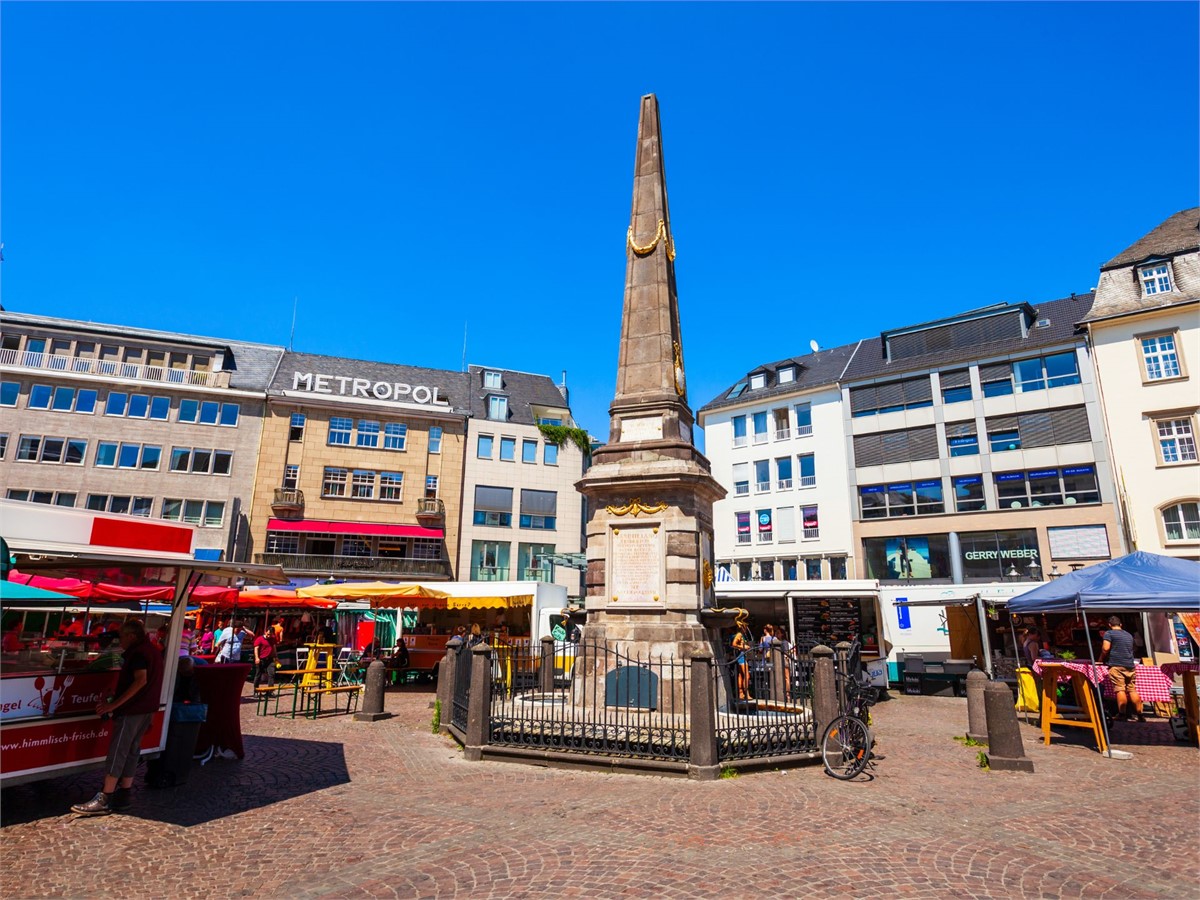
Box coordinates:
[698,344,858,581]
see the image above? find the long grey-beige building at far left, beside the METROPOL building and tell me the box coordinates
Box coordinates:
[0,312,283,562]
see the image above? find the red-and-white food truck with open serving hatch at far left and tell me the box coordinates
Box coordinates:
[0,500,282,786]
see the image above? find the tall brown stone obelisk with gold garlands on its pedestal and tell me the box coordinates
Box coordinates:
[576,94,725,672]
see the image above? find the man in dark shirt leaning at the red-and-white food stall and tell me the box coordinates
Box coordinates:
[71,619,162,816]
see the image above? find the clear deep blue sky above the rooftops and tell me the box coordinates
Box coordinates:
[0,2,1200,448]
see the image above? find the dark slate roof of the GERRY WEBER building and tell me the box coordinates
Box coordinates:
[842,294,1093,383]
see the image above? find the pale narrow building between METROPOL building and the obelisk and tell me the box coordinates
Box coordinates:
[458,366,587,598]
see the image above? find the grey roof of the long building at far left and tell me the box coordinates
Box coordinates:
[0,310,284,391]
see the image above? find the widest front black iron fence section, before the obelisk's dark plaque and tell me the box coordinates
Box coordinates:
[488,642,690,762]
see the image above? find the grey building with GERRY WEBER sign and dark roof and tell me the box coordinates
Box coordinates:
[841,294,1123,583]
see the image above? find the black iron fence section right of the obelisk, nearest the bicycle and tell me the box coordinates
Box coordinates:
[713,647,818,762]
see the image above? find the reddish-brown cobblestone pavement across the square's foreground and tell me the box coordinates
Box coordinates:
[0,690,1200,900]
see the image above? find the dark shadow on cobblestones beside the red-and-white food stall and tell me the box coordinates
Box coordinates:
[0,736,350,828]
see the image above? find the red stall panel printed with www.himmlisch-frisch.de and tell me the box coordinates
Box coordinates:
[0,712,166,775]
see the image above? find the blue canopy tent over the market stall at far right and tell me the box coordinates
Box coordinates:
[1008,550,1200,758]
